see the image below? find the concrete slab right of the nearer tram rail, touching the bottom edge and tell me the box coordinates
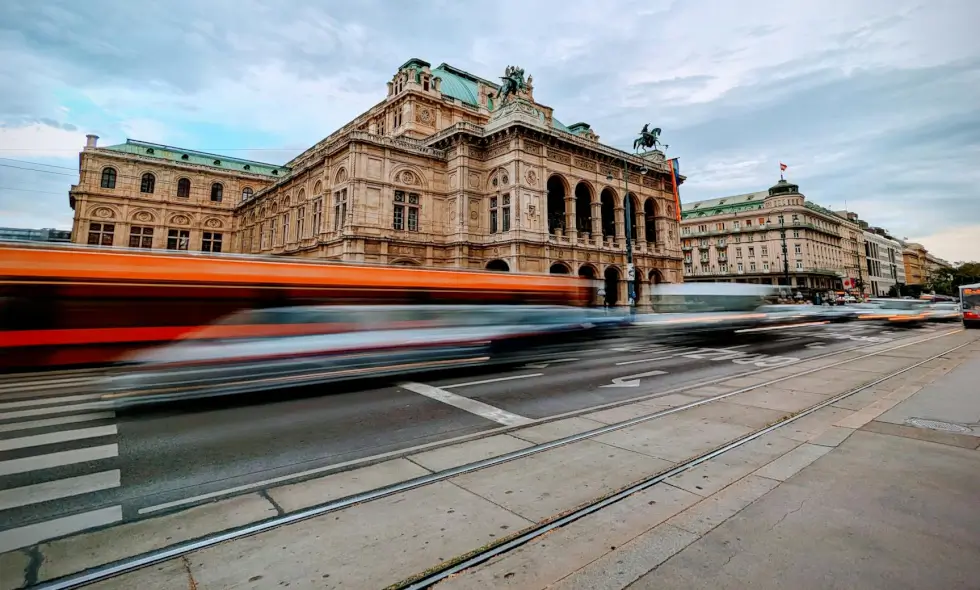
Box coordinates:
[438,485,700,590]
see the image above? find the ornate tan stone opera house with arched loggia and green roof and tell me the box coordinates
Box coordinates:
[72,59,683,304]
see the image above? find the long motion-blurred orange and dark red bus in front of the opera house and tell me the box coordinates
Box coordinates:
[0,243,589,371]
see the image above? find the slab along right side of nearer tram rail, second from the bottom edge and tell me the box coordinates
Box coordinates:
[667,433,800,497]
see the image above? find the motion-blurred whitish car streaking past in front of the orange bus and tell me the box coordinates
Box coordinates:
[101,305,626,406]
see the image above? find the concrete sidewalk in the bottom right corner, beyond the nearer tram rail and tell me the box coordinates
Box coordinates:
[439,342,980,590]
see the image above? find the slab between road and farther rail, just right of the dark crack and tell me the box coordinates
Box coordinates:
[268,459,429,512]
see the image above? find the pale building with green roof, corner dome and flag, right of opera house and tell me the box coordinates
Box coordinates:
[681,180,863,295]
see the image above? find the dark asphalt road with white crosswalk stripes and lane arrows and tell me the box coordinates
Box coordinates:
[0,324,942,552]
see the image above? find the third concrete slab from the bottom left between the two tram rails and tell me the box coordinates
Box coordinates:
[450,440,672,522]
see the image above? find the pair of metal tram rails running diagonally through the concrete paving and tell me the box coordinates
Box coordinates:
[28,329,972,590]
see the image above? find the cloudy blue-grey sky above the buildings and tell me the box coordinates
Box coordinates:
[0,0,980,261]
